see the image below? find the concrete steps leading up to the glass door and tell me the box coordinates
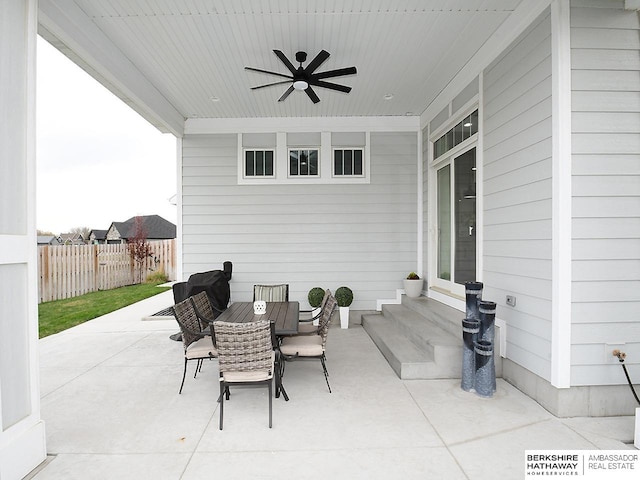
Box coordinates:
[362,305,462,379]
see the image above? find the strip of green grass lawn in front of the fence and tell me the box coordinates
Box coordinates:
[38,283,170,338]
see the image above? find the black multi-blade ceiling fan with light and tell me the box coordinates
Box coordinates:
[244,50,357,103]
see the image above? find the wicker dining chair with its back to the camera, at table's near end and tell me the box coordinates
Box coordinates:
[214,320,275,430]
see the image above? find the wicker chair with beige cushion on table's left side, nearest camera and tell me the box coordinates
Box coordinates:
[172,298,218,393]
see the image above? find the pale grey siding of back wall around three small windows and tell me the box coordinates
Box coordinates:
[182,132,418,309]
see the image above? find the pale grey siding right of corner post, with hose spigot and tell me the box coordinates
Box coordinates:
[571,1,640,385]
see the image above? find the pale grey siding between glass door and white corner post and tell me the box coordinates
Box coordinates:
[483,12,552,379]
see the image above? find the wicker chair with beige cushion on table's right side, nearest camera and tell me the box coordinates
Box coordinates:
[279,290,337,393]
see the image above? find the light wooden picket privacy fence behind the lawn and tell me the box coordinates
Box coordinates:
[38,239,176,303]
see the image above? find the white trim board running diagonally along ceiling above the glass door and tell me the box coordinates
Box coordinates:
[420,0,551,127]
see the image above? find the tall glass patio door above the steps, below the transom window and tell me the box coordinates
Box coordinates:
[436,147,477,294]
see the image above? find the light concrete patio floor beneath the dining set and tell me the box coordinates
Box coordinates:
[28,292,635,480]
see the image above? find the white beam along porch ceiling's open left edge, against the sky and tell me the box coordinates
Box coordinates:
[38,0,184,137]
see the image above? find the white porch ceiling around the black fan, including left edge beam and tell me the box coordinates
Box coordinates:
[39,0,548,134]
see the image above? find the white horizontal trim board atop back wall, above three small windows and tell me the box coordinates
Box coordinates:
[184,116,420,135]
